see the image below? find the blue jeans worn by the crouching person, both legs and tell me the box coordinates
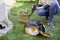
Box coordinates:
[38,2,60,21]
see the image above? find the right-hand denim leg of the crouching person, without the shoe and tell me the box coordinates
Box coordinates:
[49,2,58,21]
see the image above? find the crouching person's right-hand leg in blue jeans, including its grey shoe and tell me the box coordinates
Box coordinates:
[48,2,58,28]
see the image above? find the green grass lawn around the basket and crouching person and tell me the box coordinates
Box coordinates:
[0,2,60,40]
